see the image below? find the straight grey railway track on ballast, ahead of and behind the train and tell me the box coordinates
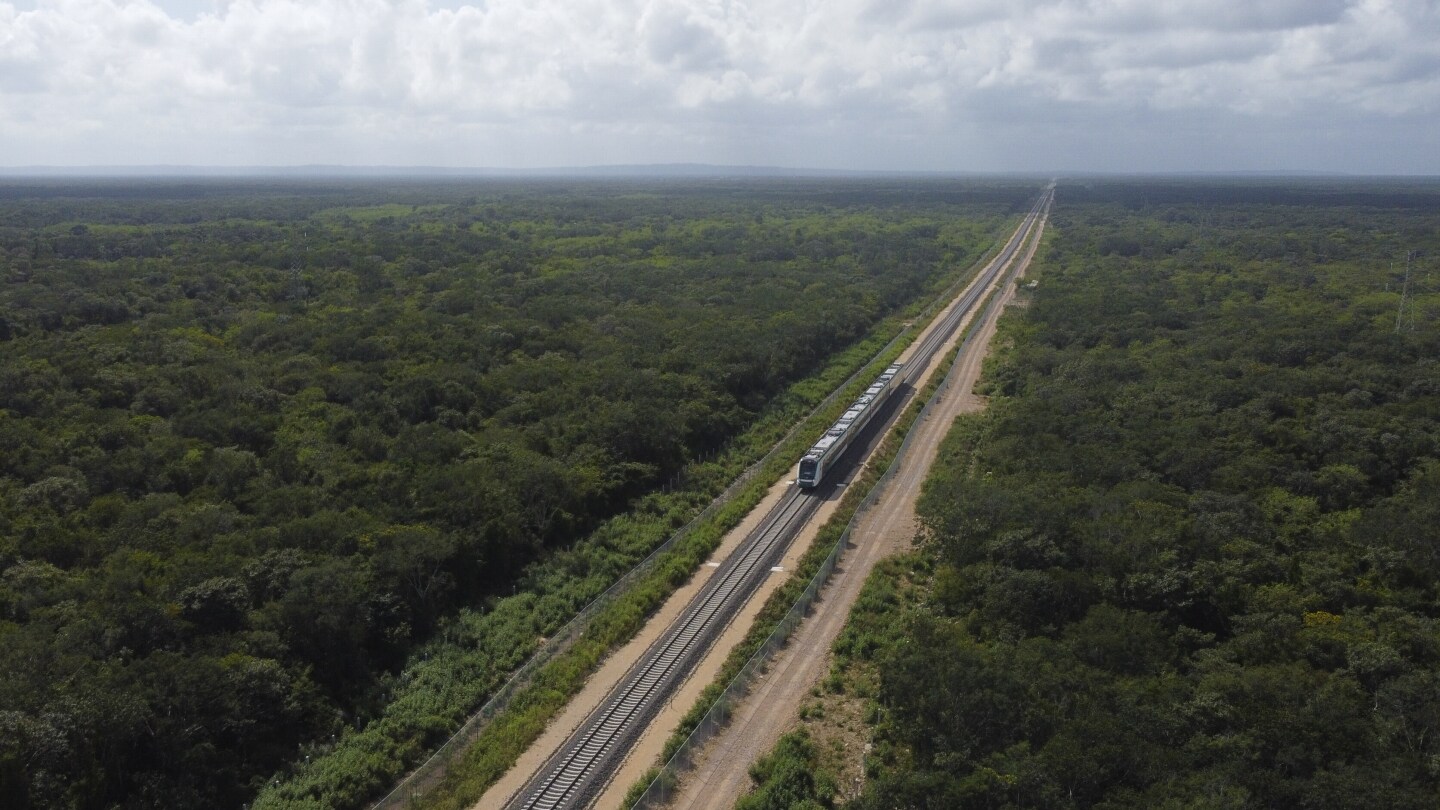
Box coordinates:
[505,189,1054,810]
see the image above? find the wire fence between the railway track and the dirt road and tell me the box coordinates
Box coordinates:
[631,240,1009,810]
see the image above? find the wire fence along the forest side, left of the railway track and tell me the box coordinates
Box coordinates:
[372,221,1013,810]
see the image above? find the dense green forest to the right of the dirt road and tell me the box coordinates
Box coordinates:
[742,182,1440,810]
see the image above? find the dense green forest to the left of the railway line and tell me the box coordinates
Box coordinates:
[0,180,1025,810]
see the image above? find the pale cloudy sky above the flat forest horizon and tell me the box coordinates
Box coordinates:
[0,0,1440,174]
